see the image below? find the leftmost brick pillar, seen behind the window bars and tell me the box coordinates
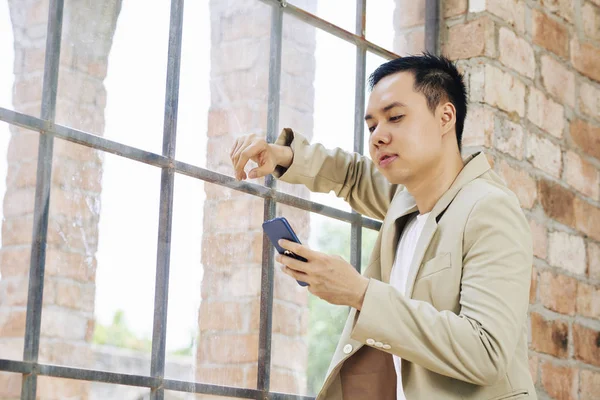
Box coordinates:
[0,0,121,399]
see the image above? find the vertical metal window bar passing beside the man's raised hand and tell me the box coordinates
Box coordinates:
[256,1,283,398]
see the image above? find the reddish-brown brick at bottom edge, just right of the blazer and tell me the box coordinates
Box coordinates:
[540,361,579,400]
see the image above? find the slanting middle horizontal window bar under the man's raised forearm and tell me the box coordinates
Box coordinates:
[0,107,381,230]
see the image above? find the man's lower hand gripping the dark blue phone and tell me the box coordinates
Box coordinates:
[276,239,369,310]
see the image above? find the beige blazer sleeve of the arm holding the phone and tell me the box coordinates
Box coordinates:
[351,193,533,385]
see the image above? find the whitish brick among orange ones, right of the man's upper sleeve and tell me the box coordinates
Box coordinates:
[548,232,586,275]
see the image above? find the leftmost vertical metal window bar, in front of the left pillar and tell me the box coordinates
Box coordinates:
[21,0,64,400]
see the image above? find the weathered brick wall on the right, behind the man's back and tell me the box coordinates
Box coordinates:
[442,0,600,399]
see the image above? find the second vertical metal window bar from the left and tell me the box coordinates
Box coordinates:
[150,0,184,400]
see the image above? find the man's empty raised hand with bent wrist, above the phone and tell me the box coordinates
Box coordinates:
[229,134,294,181]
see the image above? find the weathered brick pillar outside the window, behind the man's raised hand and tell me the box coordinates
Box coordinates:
[196,0,316,393]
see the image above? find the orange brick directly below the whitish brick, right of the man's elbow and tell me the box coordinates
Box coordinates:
[539,271,577,315]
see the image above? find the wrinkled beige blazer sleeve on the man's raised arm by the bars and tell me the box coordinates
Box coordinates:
[273,128,399,220]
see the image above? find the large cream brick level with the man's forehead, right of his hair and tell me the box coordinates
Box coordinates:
[484,65,525,117]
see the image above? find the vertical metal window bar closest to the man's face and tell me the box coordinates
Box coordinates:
[350,0,367,272]
